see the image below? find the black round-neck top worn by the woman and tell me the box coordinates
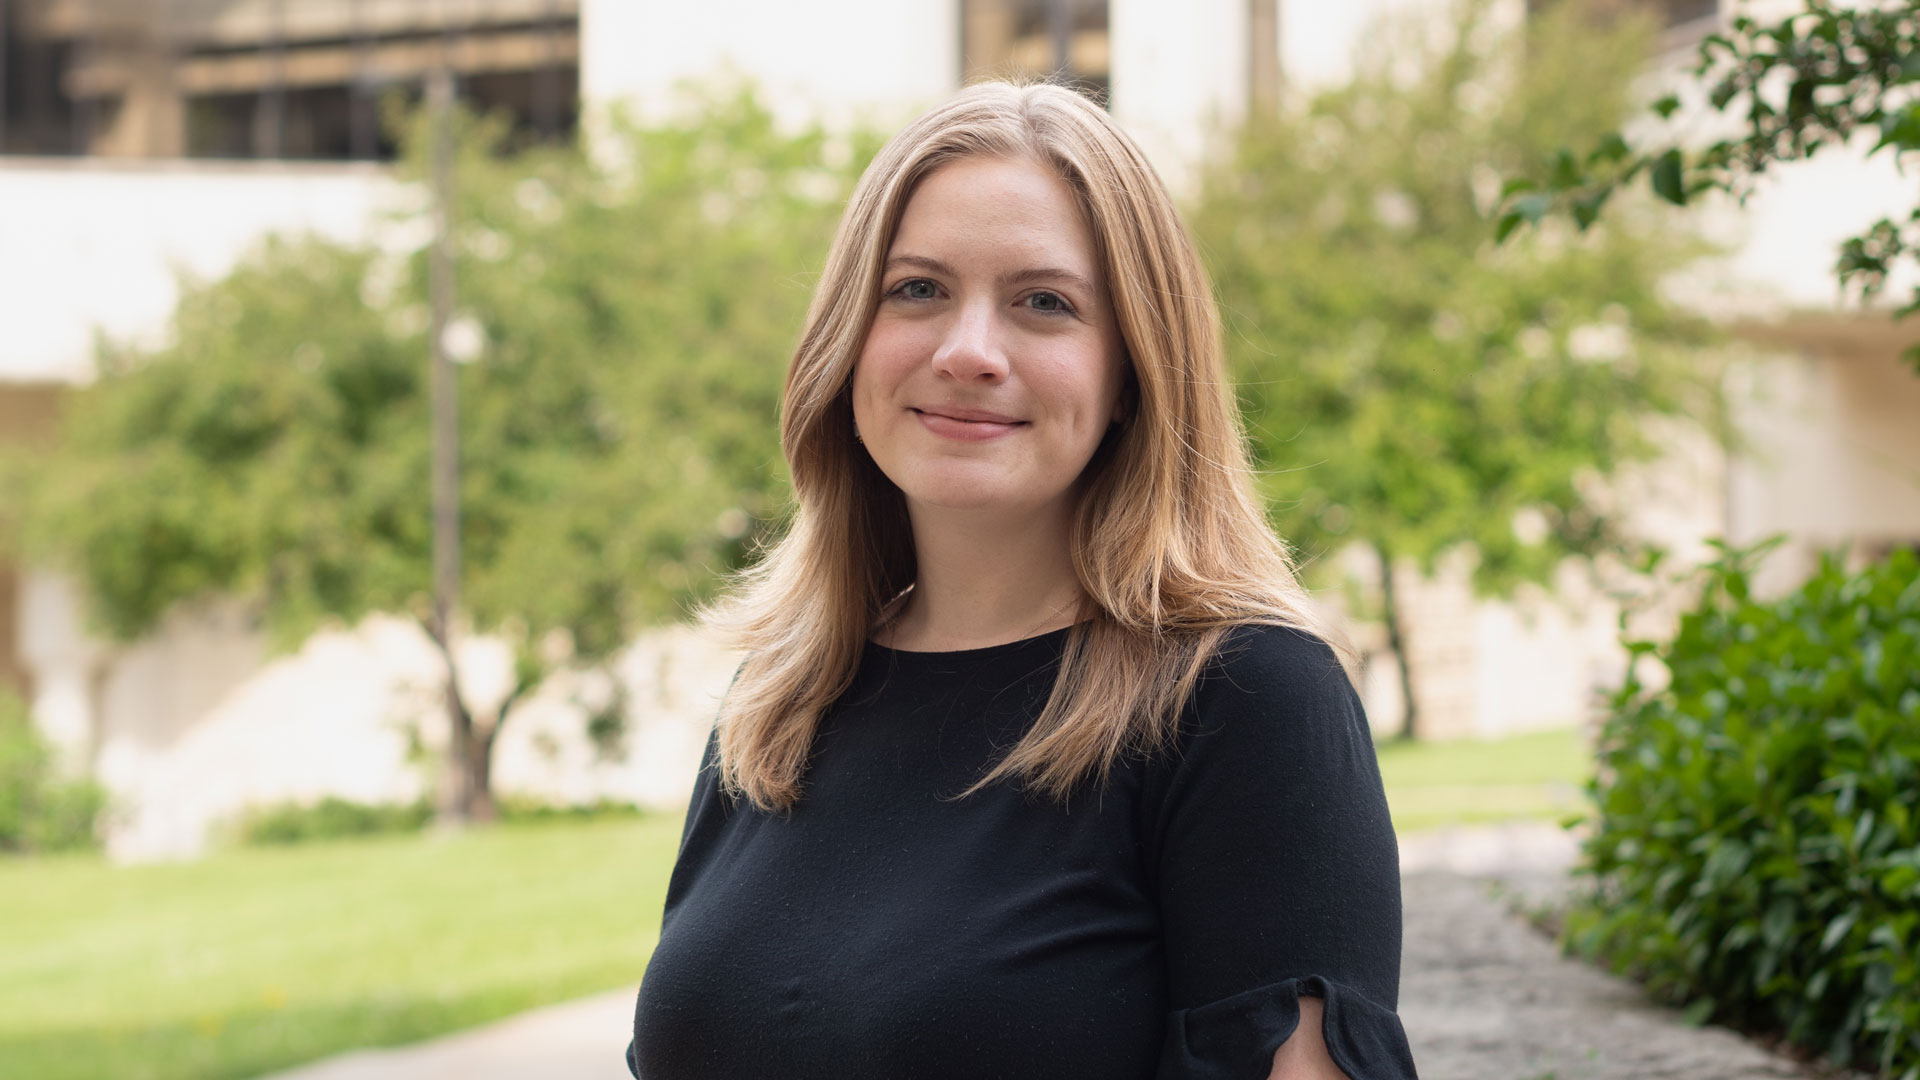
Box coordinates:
[628,626,1413,1080]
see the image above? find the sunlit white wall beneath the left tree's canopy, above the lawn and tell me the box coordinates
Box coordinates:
[96,609,739,861]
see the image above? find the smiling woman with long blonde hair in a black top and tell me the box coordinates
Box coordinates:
[628,85,1413,1080]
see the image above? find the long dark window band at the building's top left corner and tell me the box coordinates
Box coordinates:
[0,0,580,160]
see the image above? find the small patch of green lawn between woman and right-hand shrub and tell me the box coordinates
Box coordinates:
[1379,730,1594,832]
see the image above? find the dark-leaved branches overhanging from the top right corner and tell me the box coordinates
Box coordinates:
[1498,0,1920,371]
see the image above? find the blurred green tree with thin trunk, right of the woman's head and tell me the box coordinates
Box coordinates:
[1192,0,1716,736]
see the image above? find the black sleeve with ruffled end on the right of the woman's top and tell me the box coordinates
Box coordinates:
[1146,626,1415,1080]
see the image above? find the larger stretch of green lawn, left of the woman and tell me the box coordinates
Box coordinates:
[0,817,680,1080]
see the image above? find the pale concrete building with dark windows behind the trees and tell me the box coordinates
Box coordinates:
[0,0,1920,857]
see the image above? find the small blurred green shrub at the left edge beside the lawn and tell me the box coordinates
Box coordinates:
[0,690,108,853]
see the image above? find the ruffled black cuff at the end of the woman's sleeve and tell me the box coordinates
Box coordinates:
[1156,974,1417,1080]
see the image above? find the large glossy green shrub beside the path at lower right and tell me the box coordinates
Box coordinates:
[1567,546,1920,1080]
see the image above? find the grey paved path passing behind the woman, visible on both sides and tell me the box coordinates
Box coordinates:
[259,826,1843,1080]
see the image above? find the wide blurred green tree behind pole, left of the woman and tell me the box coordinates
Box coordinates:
[23,90,868,819]
